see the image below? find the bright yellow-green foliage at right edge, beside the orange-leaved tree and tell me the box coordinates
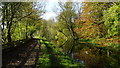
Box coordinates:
[104,5,120,37]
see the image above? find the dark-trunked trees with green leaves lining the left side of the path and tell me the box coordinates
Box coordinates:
[1,2,43,42]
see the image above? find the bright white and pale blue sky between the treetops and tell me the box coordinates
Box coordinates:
[42,0,82,21]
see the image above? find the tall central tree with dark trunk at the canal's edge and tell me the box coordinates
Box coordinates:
[58,2,77,39]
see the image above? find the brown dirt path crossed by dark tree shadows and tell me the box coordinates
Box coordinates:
[2,40,40,68]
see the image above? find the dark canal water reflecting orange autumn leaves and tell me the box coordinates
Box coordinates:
[63,40,120,68]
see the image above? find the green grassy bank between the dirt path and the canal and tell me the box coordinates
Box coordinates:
[36,40,83,68]
